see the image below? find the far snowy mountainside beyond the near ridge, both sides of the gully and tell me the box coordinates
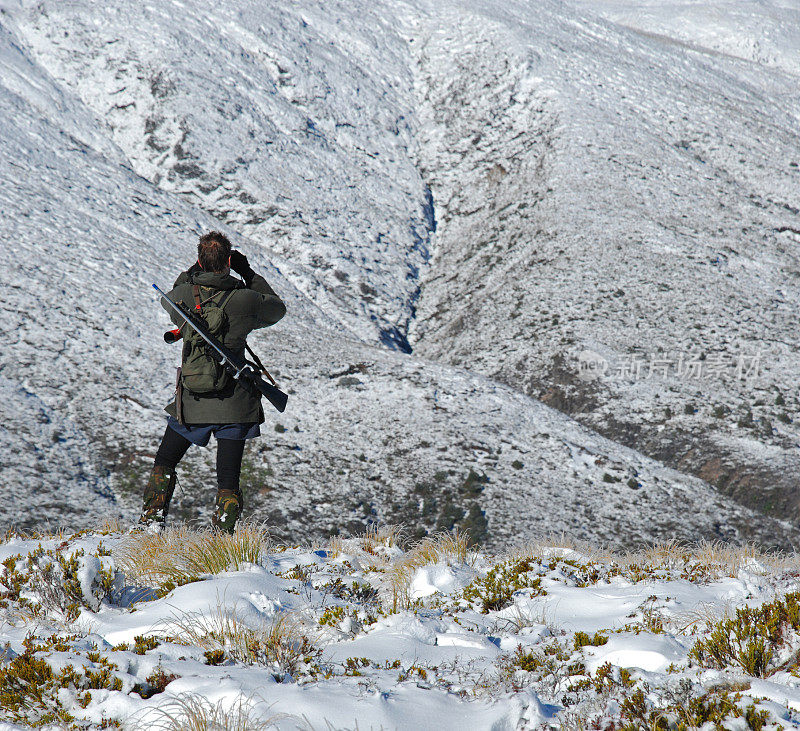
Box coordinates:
[10,0,800,528]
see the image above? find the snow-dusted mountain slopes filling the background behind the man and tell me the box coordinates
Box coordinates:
[0,0,798,546]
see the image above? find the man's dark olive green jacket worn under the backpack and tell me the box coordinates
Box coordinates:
[162,272,286,424]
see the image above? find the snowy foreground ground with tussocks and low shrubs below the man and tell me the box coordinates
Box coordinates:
[0,533,800,731]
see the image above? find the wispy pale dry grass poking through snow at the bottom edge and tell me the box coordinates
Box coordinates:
[134,693,291,731]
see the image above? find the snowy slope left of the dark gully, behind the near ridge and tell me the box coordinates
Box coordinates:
[9,1,433,348]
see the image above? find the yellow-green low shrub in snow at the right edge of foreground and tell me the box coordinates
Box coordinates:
[689,593,800,678]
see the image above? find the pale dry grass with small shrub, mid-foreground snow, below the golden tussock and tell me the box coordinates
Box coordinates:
[161,604,321,675]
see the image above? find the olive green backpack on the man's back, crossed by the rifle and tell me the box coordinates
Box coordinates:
[181,284,236,396]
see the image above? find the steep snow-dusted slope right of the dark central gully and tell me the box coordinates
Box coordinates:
[404,2,800,518]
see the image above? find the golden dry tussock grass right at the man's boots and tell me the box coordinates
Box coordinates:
[114,523,270,587]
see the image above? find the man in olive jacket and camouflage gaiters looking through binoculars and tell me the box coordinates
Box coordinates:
[139,231,286,533]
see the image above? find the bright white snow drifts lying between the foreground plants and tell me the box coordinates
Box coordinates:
[0,533,800,731]
